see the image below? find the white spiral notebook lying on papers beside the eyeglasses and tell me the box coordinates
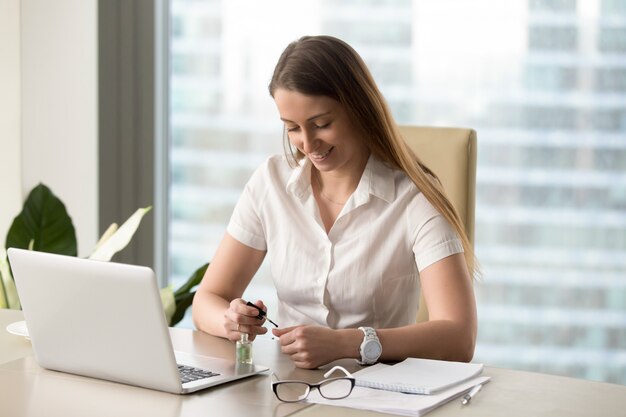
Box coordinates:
[356,358,483,395]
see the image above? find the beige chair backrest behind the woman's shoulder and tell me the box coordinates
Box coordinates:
[400,126,476,322]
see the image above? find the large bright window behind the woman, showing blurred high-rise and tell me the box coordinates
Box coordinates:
[168,0,626,384]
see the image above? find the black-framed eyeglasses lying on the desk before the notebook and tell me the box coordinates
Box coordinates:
[271,366,354,403]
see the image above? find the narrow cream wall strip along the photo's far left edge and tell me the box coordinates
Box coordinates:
[0,0,22,247]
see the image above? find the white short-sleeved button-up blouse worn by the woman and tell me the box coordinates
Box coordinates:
[227,155,463,328]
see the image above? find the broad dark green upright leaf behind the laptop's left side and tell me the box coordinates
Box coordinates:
[5,184,77,256]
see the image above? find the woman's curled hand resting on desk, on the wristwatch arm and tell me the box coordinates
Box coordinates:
[272,326,341,369]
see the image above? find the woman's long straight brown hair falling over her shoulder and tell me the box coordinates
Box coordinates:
[269,36,476,276]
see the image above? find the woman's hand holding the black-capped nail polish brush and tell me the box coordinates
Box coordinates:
[224,298,267,341]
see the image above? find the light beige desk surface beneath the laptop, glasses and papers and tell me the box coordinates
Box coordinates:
[0,310,626,417]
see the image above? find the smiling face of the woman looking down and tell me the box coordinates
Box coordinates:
[274,88,369,175]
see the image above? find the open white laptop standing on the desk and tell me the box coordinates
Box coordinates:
[8,248,268,394]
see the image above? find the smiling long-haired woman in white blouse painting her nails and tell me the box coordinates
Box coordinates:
[193,36,477,368]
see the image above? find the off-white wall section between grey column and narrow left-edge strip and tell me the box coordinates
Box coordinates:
[19,0,98,256]
